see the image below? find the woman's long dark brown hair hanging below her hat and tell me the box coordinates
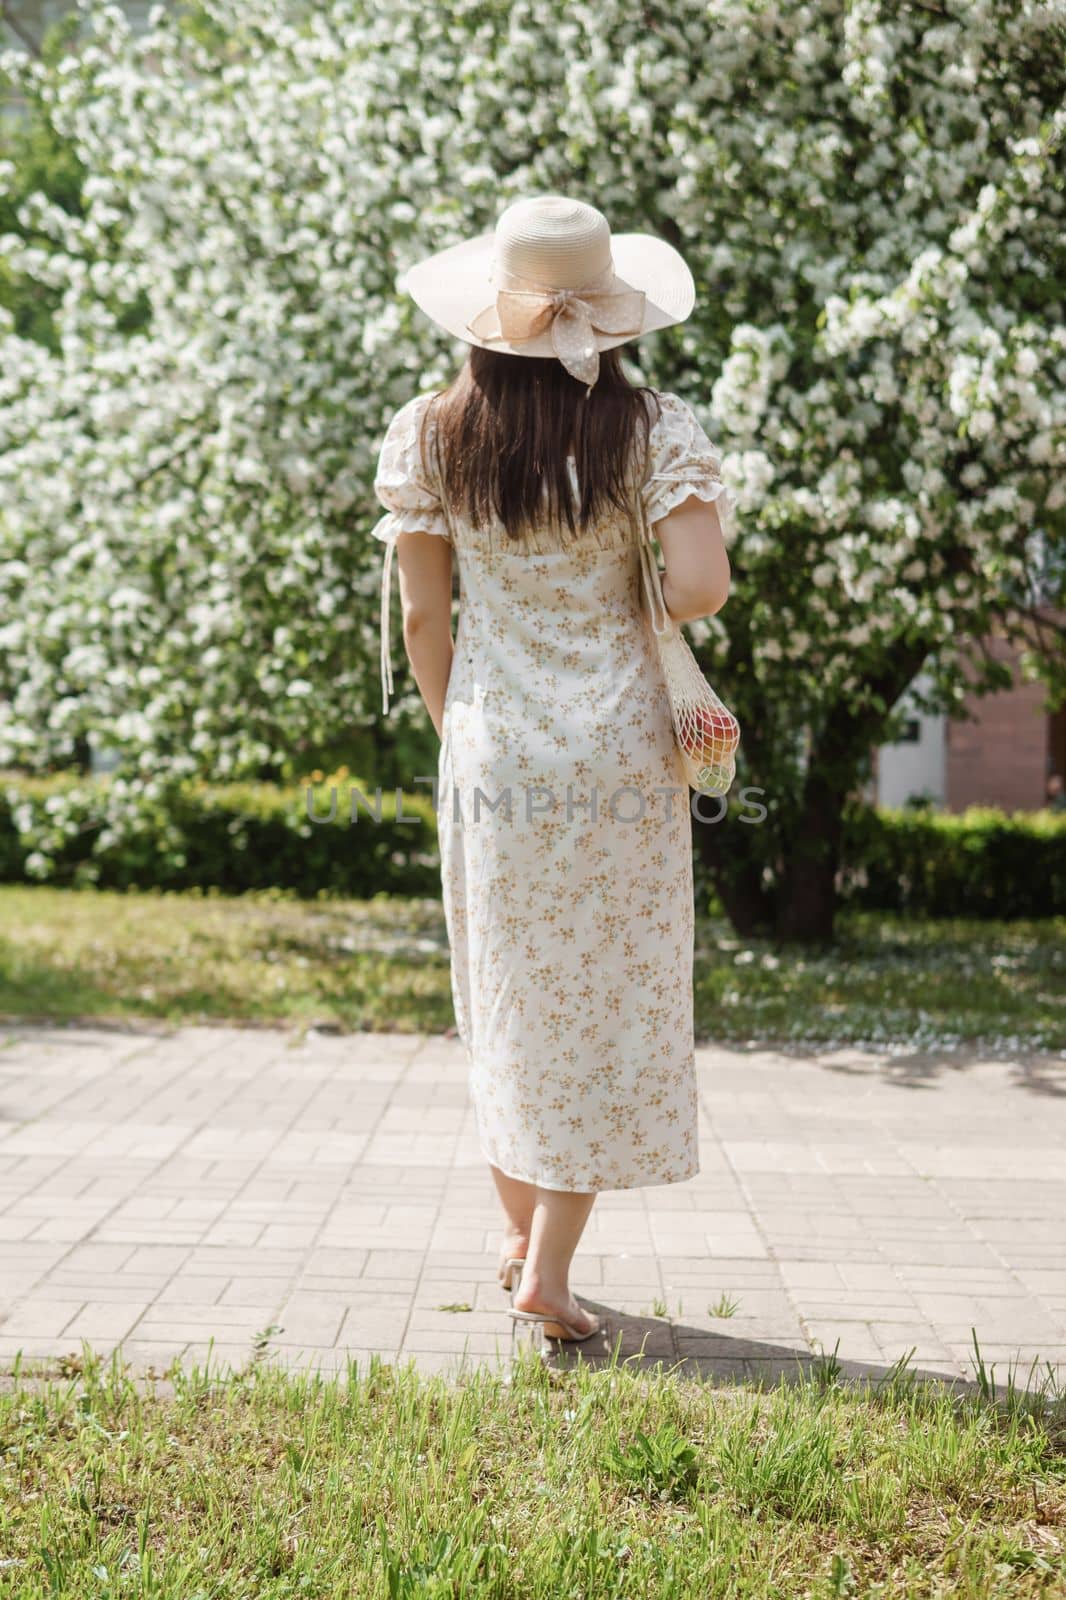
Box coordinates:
[426,344,659,539]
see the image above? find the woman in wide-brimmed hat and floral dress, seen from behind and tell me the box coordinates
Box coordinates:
[373,195,731,1339]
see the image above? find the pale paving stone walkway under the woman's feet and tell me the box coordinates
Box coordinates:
[0,1024,1066,1386]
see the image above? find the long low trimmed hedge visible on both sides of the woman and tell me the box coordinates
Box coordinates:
[0,770,1066,917]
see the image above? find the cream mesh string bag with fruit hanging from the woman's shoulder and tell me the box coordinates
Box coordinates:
[635,435,739,795]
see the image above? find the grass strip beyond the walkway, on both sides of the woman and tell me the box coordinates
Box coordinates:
[0,886,1066,1050]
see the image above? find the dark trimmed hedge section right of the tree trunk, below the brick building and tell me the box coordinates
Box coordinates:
[840,806,1066,917]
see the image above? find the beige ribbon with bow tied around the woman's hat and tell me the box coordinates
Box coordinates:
[467,290,643,392]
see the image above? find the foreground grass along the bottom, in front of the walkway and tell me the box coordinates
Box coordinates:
[0,1347,1066,1600]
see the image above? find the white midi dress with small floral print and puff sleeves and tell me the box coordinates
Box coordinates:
[373,392,733,1192]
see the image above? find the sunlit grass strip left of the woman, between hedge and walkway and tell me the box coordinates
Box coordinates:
[0,888,453,1032]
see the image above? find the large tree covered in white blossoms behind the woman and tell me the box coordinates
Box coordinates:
[0,0,1066,936]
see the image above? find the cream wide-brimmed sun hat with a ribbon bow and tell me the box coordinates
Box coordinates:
[400,195,696,389]
